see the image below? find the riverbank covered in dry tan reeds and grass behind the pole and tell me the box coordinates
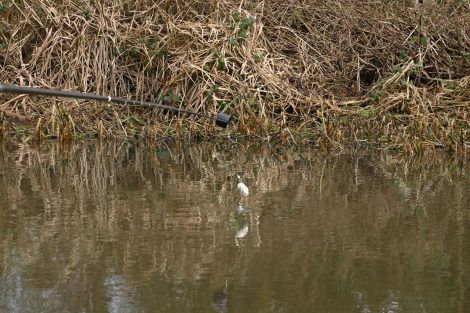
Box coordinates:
[0,0,470,153]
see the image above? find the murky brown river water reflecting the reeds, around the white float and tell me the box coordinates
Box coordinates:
[0,143,470,313]
